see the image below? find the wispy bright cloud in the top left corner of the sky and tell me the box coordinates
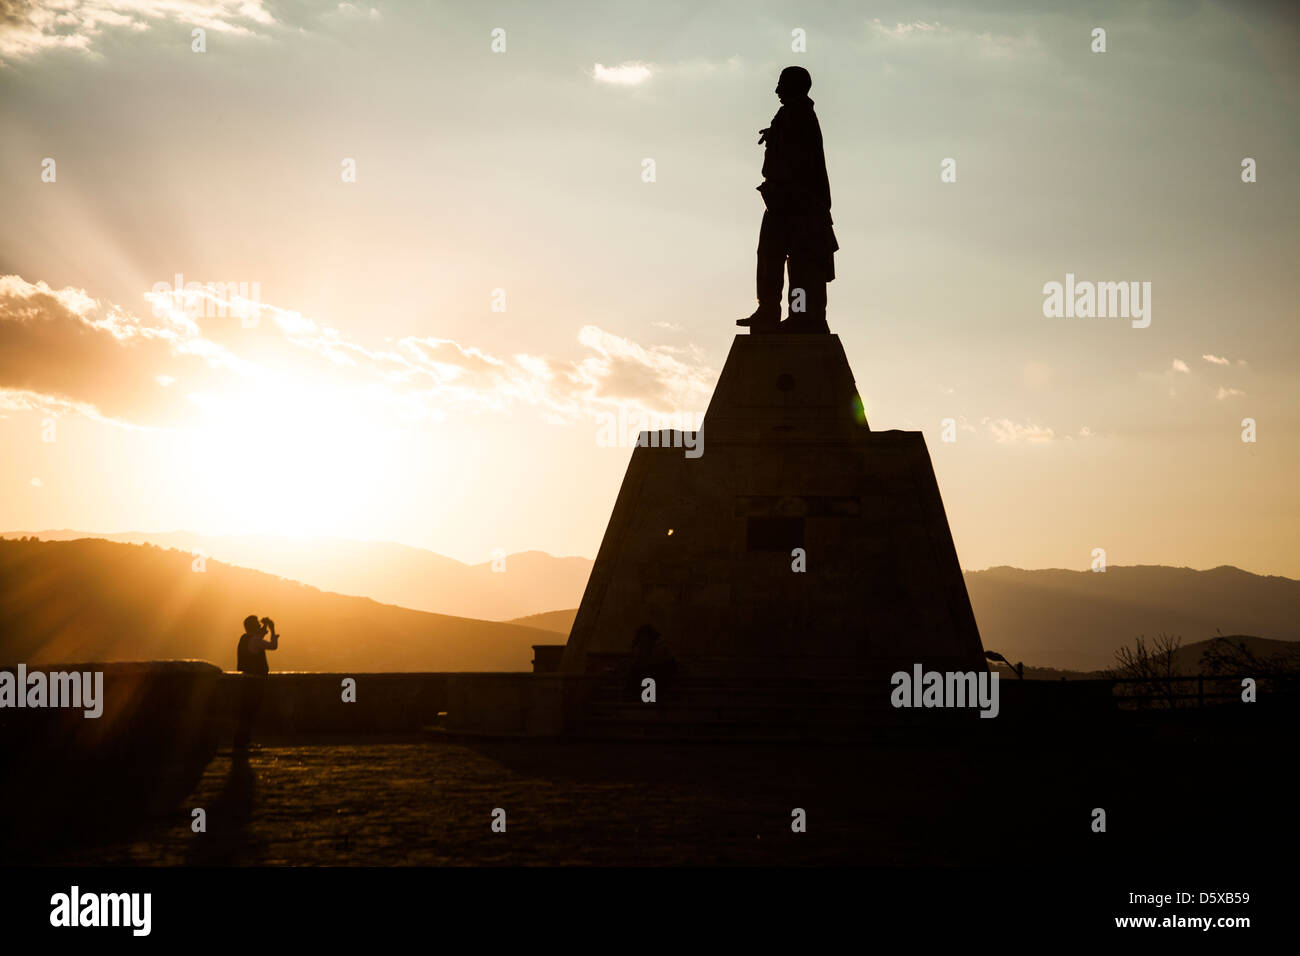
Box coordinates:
[0,0,276,59]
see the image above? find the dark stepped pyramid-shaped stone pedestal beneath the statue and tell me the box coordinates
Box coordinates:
[560,334,987,683]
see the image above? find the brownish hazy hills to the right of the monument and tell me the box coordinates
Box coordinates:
[966,566,1300,671]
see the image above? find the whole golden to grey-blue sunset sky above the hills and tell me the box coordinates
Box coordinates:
[0,0,1300,578]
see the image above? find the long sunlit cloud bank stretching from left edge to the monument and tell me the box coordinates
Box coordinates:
[0,276,715,427]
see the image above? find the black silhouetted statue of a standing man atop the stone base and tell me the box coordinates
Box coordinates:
[736,66,840,332]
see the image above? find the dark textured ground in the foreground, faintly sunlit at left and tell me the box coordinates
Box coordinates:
[35,727,1296,869]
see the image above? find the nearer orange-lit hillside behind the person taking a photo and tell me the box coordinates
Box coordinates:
[0,540,555,671]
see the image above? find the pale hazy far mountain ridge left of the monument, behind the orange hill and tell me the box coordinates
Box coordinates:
[4,531,592,620]
